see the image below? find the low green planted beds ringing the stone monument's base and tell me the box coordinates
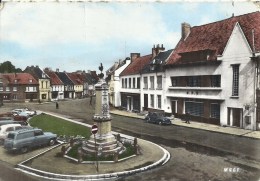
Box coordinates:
[67,143,135,161]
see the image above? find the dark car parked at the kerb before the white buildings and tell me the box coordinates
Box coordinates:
[145,112,172,125]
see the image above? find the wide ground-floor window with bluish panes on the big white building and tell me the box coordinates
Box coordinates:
[185,101,204,117]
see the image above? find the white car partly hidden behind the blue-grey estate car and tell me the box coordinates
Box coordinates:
[0,124,32,144]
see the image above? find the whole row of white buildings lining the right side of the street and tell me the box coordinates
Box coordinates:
[107,12,260,130]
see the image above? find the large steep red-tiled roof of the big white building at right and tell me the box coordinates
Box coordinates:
[167,12,260,64]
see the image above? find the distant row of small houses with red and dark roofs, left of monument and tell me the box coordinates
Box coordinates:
[0,66,98,103]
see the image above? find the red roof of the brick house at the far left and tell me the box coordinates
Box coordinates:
[2,73,38,85]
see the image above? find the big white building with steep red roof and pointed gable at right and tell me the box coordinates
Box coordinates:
[165,12,260,130]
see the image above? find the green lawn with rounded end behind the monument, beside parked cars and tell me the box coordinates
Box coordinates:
[30,114,91,138]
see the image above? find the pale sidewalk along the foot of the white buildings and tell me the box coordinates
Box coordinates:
[110,109,260,139]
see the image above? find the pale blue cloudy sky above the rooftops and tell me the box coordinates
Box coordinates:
[0,1,259,72]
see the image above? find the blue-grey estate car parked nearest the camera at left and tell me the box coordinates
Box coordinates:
[4,128,57,153]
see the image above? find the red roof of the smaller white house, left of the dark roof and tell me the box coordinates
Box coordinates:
[120,54,152,76]
